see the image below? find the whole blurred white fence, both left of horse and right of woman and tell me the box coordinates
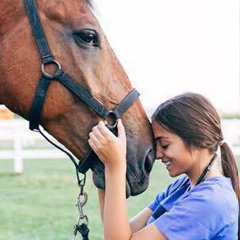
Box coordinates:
[0,119,240,173]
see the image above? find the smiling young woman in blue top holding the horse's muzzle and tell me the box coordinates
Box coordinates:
[89,93,239,240]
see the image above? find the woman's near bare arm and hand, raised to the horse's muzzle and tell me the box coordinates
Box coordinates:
[89,121,167,240]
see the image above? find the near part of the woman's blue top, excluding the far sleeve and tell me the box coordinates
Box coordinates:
[156,177,238,239]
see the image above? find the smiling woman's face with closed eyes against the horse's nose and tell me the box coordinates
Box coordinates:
[152,120,196,177]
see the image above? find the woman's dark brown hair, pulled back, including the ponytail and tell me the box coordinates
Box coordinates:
[152,93,240,239]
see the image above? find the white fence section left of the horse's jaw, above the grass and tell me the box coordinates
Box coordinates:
[0,119,66,173]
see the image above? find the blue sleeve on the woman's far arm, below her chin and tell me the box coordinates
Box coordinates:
[147,176,187,211]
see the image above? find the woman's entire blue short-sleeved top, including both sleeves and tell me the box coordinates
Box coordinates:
[147,176,239,240]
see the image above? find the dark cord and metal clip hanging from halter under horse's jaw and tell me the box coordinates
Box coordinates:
[38,129,89,240]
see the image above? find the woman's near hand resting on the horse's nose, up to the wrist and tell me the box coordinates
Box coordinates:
[88,119,127,169]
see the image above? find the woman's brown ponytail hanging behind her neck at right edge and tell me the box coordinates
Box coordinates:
[220,142,240,239]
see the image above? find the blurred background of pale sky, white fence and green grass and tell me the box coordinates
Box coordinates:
[0,0,240,240]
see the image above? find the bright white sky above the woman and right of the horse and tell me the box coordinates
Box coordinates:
[94,0,240,112]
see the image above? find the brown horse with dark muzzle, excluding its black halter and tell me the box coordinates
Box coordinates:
[0,0,155,195]
